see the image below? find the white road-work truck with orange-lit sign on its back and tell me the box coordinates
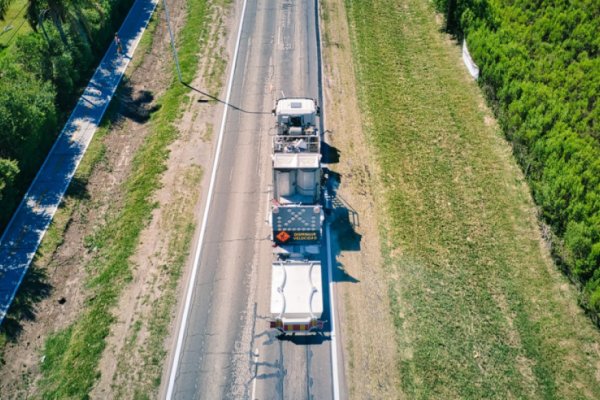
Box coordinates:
[270,98,325,334]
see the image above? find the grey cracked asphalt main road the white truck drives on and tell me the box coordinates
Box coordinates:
[166,0,340,399]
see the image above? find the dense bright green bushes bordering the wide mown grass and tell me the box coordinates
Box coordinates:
[435,0,600,314]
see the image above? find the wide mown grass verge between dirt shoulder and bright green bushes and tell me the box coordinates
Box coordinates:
[345,0,600,399]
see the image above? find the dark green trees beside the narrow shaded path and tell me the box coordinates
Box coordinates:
[0,0,133,230]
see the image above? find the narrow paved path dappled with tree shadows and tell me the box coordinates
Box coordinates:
[0,0,158,324]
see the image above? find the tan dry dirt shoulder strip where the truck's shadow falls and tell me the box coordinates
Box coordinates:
[321,0,403,399]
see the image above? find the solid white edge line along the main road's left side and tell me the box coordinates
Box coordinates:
[166,0,247,400]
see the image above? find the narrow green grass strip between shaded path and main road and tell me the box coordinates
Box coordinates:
[39,0,208,398]
